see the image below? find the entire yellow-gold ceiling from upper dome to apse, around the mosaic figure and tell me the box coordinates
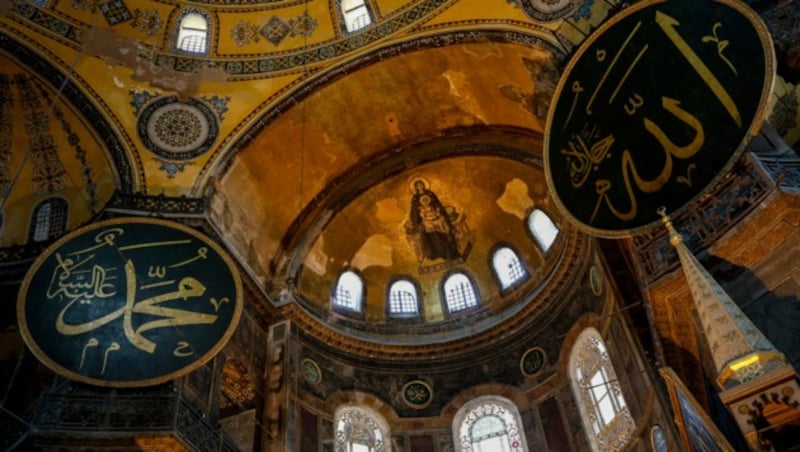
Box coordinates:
[0,0,607,346]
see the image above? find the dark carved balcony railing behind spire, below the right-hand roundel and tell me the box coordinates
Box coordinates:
[632,153,776,282]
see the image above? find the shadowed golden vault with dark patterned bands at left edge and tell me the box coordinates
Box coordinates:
[0,55,117,246]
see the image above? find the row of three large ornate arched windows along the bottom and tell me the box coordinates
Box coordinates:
[334,327,635,452]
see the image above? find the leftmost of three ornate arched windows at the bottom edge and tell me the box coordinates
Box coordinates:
[335,406,391,452]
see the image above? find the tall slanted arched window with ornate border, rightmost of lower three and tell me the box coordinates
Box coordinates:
[569,328,636,451]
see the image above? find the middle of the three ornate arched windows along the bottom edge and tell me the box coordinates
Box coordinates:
[453,396,528,452]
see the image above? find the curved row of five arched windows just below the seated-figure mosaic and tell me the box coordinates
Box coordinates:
[332,209,558,318]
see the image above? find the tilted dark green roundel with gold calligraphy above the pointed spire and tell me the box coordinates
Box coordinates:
[544,0,775,237]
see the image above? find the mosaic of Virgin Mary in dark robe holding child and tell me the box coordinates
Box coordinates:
[404,177,472,273]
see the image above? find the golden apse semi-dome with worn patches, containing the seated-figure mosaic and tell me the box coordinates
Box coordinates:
[206,41,577,346]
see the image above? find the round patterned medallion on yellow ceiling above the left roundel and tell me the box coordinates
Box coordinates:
[136,96,219,160]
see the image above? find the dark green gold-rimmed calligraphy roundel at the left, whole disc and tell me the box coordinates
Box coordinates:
[17,218,242,387]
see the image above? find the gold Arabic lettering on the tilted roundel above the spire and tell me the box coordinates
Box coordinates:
[559,11,742,224]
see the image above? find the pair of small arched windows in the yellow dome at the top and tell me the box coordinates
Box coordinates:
[175,0,373,55]
